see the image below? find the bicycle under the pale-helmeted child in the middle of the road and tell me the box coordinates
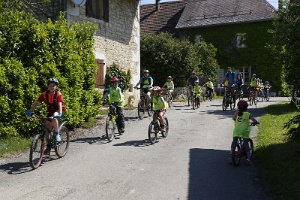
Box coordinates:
[148,110,169,144]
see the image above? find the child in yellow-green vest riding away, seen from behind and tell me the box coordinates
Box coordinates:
[229,100,259,164]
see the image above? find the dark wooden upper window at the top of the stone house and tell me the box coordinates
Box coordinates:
[86,0,109,22]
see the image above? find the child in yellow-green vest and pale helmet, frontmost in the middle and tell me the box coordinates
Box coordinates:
[152,86,167,131]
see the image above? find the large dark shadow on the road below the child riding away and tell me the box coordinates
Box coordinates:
[188,148,272,200]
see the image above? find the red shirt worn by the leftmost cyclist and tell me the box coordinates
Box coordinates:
[38,91,66,113]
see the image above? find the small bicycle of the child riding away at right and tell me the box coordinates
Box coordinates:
[231,123,256,166]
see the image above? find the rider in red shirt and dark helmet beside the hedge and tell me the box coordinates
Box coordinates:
[26,78,66,143]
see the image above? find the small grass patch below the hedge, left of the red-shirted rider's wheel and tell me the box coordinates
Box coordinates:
[0,137,33,157]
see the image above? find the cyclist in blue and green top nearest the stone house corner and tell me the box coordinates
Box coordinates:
[134,70,153,111]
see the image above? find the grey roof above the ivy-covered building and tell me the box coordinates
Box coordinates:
[176,0,276,29]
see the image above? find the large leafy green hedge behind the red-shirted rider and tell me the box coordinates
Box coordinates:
[0,3,100,136]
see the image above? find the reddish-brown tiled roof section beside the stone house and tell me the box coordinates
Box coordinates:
[140,0,186,35]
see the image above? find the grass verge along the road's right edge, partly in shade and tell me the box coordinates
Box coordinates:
[255,103,300,199]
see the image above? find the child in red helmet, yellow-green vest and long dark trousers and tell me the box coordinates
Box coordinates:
[101,77,125,133]
